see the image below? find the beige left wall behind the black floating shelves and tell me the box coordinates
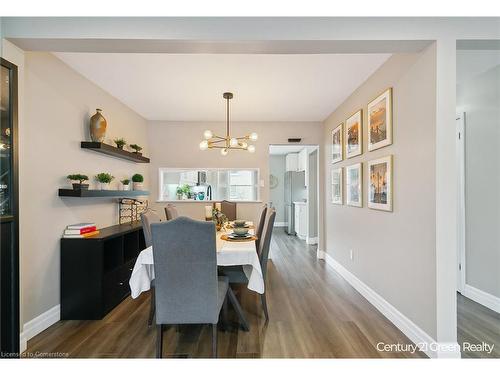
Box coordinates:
[19,48,149,326]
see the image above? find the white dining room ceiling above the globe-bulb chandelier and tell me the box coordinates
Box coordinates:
[55,53,390,122]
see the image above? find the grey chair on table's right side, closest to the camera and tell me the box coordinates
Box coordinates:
[219,208,276,322]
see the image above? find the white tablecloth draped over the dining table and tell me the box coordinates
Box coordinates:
[129,225,264,298]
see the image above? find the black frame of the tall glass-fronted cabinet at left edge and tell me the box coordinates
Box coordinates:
[0,58,20,357]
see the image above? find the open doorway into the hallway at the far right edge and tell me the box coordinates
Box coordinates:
[456,50,500,358]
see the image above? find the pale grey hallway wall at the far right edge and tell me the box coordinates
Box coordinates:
[457,64,500,297]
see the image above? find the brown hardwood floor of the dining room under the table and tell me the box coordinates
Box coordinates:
[28,228,425,358]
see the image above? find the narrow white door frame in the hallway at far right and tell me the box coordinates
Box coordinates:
[456,112,466,294]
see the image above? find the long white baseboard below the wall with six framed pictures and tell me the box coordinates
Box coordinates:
[318,251,461,358]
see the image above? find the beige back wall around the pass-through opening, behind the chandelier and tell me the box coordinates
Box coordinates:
[148,121,322,225]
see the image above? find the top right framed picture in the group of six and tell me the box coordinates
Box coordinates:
[368,88,392,151]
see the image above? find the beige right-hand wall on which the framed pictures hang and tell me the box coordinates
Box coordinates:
[323,47,437,339]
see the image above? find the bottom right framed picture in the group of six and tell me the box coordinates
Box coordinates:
[368,155,392,211]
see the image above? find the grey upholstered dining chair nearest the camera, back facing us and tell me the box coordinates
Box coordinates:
[151,217,234,358]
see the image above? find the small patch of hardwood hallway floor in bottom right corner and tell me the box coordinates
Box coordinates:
[457,293,500,358]
